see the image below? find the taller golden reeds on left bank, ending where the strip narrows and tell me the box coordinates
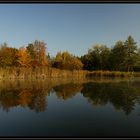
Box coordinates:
[0,67,88,79]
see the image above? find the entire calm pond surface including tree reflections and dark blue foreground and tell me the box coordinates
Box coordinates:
[0,78,140,137]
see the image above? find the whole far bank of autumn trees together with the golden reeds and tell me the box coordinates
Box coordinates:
[0,36,140,79]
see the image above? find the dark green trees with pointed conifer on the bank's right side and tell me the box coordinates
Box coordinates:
[81,36,140,71]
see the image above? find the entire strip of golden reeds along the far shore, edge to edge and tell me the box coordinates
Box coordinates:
[0,67,137,79]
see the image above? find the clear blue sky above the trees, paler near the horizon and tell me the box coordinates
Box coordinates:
[0,3,140,56]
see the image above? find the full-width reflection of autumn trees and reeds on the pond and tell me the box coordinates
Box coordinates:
[0,79,140,115]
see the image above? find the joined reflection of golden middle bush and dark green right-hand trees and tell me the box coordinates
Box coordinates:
[53,81,140,115]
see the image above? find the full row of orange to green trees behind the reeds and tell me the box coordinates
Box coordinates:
[0,36,140,71]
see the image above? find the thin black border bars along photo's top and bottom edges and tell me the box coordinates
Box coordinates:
[0,0,140,140]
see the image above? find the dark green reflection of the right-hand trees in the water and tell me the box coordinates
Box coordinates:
[81,82,140,115]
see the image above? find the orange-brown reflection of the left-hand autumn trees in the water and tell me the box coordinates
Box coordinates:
[0,86,49,112]
